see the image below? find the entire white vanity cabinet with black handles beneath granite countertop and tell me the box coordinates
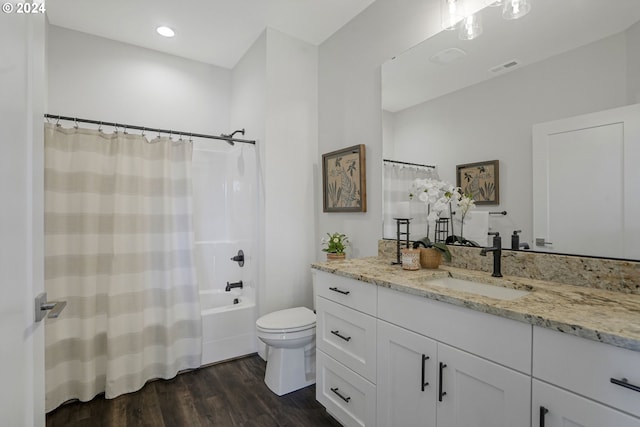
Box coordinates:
[314,270,640,427]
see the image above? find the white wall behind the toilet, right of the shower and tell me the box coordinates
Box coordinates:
[232,29,317,314]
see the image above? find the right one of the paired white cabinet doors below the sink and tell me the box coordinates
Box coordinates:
[437,344,531,427]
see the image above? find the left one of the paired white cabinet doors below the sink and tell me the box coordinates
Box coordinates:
[377,320,438,427]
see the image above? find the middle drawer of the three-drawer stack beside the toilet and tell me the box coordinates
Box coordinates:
[316,297,376,383]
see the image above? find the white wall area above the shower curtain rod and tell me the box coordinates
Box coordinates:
[47,26,231,133]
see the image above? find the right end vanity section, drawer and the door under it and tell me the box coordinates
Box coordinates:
[532,327,640,427]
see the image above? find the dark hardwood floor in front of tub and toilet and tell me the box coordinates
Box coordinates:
[47,355,340,427]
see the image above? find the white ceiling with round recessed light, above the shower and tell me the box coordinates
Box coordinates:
[47,0,375,68]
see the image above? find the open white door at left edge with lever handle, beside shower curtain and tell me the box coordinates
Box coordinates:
[0,13,45,427]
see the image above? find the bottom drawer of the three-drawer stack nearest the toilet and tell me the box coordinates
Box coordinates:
[316,351,376,427]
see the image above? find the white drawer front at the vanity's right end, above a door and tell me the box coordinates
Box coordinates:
[533,327,640,417]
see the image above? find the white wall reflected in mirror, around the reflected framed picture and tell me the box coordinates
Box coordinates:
[393,34,627,248]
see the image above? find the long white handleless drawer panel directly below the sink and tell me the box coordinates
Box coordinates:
[378,288,532,374]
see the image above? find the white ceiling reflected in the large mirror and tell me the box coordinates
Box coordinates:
[382,0,640,112]
